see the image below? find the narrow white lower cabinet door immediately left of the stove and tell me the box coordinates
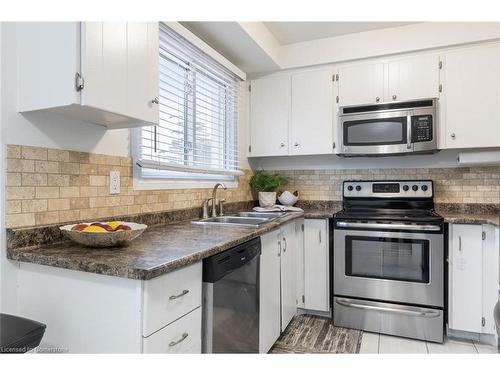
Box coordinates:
[304,219,330,311]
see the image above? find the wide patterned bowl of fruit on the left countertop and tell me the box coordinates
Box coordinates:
[59,221,148,247]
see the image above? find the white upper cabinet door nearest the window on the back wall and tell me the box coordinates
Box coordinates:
[249,74,290,156]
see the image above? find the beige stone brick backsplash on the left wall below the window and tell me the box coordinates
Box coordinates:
[5,145,253,228]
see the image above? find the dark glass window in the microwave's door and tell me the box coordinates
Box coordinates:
[343,117,407,146]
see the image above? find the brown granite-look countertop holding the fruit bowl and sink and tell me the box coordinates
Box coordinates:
[7,209,333,280]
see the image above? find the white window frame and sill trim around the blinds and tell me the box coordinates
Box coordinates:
[131,22,246,190]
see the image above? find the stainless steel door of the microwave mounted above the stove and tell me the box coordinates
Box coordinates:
[339,111,413,155]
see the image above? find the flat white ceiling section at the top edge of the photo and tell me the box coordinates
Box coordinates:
[264,22,417,45]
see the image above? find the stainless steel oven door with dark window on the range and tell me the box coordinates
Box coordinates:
[334,229,444,307]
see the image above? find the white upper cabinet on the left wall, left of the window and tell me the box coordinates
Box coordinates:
[17,22,159,128]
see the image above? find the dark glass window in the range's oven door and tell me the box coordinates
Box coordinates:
[345,236,429,284]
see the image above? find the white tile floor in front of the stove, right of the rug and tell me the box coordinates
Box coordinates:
[359,332,500,354]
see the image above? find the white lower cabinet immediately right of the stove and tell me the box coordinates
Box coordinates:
[448,224,499,334]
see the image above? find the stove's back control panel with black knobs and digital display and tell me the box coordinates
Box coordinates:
[343,180,433,198]
